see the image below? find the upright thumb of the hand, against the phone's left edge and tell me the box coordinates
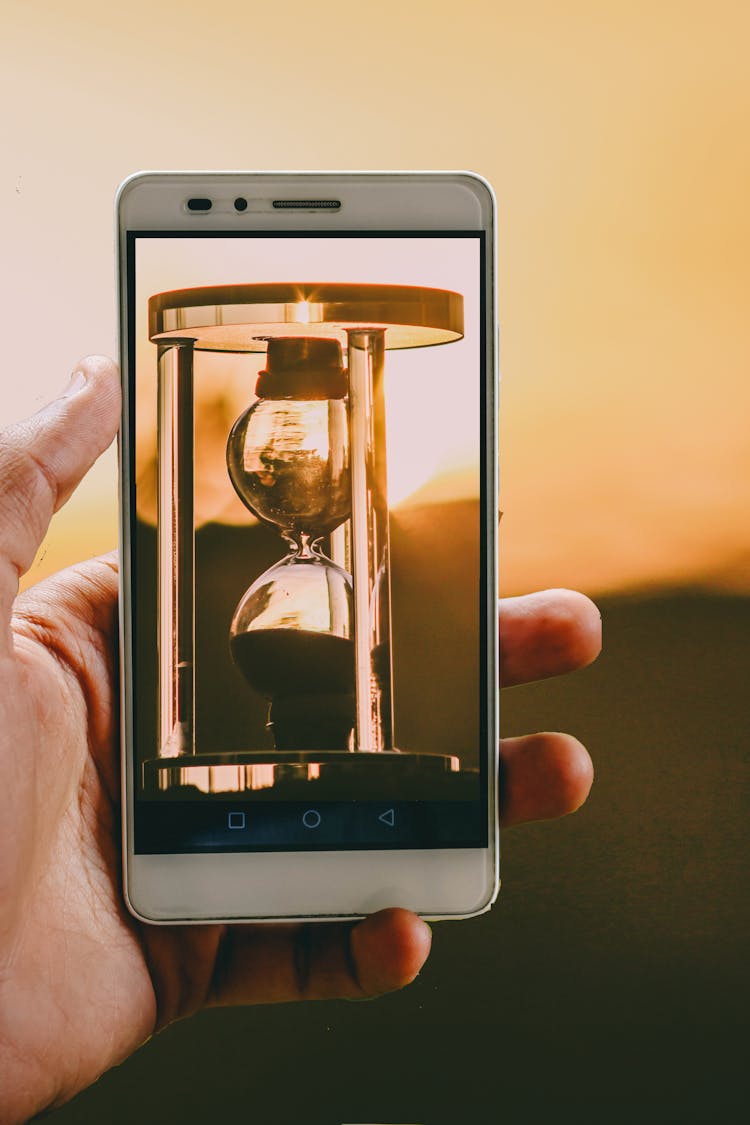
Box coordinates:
[0,356,120,622]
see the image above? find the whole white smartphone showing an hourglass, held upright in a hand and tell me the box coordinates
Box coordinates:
[116,172,499,923]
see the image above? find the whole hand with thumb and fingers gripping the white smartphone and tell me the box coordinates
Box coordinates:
[0,358,599,1122]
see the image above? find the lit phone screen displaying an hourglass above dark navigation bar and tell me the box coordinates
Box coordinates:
[126,231,495,854]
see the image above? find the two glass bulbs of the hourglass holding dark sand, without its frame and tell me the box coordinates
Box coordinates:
[227,336,355,750]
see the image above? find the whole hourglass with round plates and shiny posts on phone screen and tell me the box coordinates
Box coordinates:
[143,284,476,799]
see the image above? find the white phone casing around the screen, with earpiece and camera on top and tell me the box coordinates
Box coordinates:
[116,172,499,924]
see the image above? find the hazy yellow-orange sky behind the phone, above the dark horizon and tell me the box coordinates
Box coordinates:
[0,0,750,593]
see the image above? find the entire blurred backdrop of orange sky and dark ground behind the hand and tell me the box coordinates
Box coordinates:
[0,0,750,1125]
